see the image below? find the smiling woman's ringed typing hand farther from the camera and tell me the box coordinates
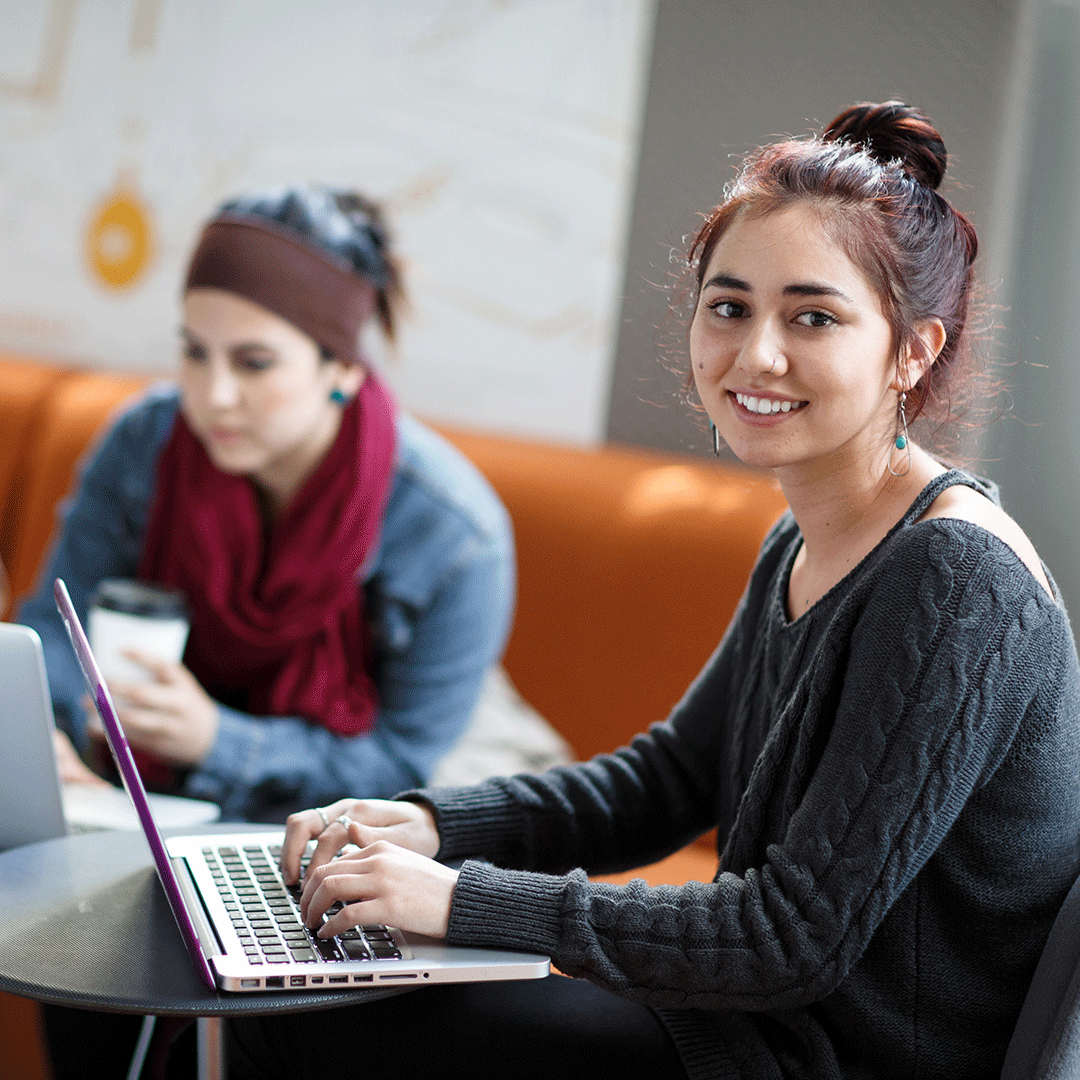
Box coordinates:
[281,799,440,885]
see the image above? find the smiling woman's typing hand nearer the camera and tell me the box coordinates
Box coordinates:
[300,825,458,937]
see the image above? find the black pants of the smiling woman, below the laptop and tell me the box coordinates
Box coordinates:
[228,975,686,1080]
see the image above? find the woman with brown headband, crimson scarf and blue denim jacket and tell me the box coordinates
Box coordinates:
[21,188,513,821]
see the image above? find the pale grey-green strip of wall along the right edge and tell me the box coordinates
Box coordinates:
[987,3,1080,621]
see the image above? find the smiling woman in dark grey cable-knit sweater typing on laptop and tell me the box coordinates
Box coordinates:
[223,102,1080,1080]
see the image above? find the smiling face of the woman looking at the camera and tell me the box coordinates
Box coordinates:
[690,205,899,483]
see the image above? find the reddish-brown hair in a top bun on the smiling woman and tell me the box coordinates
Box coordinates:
[687,102,978,422]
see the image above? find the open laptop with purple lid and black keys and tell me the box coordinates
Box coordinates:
[54,578,551,991]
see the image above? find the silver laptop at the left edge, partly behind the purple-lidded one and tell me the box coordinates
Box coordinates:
[0,622,218,851]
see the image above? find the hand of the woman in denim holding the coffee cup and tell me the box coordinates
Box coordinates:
[95,649,218,766]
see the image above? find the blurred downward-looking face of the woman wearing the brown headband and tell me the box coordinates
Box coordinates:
[180,288,363,505]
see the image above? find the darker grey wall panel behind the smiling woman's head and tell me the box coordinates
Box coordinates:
[607,0,1018,455]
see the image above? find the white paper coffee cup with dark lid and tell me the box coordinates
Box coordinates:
[86,578,189,683]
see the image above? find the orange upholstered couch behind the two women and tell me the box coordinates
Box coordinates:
[0,356,784,1077]
